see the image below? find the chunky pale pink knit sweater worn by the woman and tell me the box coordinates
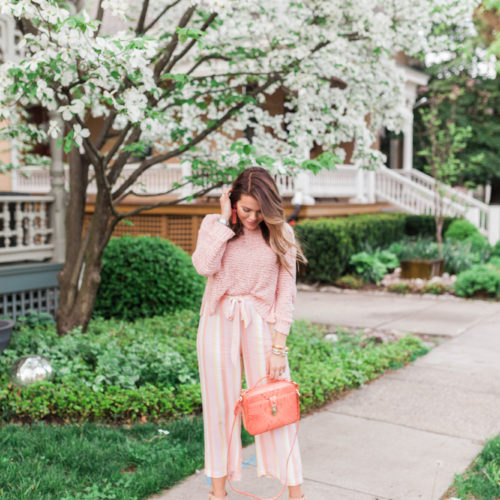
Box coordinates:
[192,214,297,335]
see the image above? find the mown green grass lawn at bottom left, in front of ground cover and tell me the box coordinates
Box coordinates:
[0,417,253,500]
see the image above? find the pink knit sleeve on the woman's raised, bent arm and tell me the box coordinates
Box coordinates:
[191,214,235,276]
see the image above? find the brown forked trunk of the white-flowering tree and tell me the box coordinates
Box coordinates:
[56,151,111,335]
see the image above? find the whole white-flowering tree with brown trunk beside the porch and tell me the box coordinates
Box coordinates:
[0,0,476,333]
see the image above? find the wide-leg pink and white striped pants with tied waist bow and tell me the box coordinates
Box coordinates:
[196,295,303,486]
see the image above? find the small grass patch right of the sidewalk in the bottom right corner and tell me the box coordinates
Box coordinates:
[443,435,500,500]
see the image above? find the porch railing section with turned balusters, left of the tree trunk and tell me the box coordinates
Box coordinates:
[0,196,54,263]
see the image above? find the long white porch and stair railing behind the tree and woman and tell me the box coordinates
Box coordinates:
[7,164,500,244]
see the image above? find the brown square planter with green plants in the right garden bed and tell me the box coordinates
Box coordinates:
[389,239,444,280]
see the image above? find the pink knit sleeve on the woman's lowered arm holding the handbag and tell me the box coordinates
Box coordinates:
[274,225,297,335]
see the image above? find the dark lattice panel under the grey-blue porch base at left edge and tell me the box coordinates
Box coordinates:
[0,287,59,319]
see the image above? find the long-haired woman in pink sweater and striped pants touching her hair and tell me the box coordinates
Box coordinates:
[192,167,307,500]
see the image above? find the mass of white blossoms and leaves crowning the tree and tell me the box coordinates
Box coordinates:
[0,0,478,179]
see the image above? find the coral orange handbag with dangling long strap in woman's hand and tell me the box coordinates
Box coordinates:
[227,376,300,500]
